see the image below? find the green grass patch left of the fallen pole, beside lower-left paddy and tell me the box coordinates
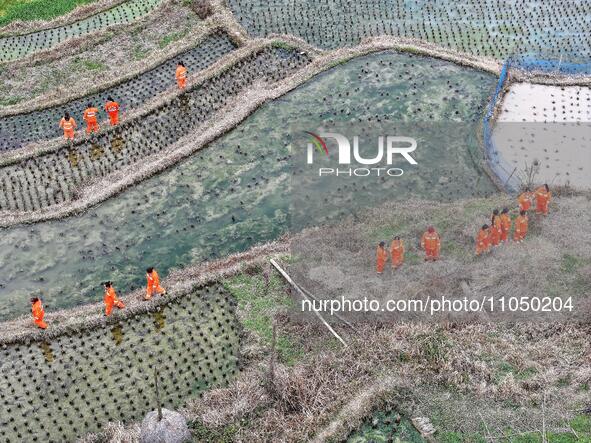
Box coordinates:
[225,272,303,365]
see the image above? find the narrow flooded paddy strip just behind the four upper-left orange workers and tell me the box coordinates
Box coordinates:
[0,32,236,151]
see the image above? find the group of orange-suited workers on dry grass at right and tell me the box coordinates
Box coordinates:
[376,184,552,274]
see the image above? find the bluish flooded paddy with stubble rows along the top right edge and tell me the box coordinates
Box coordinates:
[228,0,591,62]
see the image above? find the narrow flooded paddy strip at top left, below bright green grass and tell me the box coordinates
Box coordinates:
[0,0,164,62]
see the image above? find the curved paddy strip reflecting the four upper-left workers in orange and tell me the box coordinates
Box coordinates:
[0,48,309,211]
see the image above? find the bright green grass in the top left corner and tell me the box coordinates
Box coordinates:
[0,0,94,26]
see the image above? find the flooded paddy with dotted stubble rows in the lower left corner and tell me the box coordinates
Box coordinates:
[0,284,240,443]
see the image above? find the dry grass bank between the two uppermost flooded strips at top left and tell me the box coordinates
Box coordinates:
[0,1,204,115]
